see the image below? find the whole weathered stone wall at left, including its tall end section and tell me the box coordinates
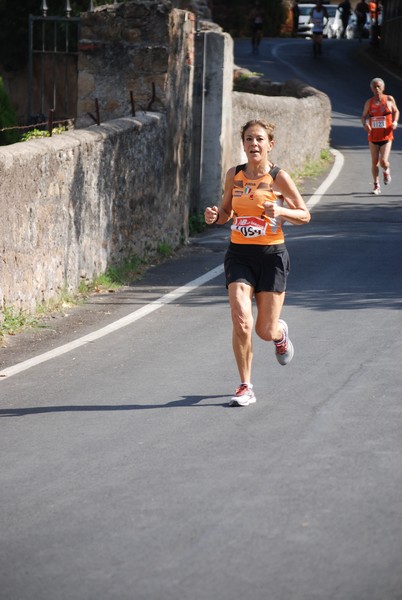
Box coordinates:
[0,0,193,318]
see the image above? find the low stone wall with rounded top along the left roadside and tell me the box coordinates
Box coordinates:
[0,114,188,310]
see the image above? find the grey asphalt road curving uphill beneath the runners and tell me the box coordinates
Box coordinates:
[0,40,402,600]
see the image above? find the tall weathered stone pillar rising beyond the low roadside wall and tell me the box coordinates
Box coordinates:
[77,0,194,247]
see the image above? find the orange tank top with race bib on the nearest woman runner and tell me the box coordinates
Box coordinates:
[230,165,285,246]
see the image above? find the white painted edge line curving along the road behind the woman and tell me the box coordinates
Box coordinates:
[0,148,344,382]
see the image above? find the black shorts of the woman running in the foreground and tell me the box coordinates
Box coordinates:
[225,243,290,292]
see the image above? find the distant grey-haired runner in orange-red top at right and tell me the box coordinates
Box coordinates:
[361,77,399,194]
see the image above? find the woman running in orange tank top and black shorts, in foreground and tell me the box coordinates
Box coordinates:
[204,120,310,406]
